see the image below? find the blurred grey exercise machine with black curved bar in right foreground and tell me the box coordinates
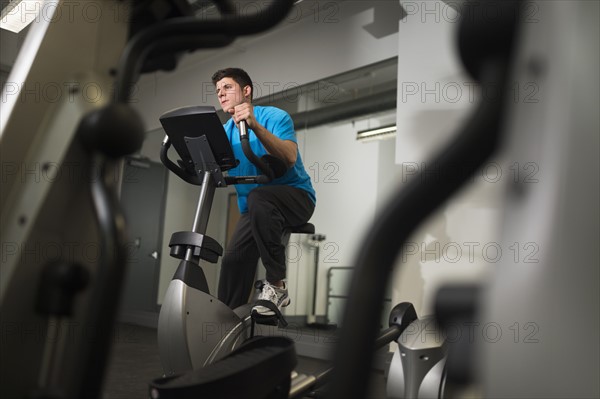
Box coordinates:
[331,1,600,398]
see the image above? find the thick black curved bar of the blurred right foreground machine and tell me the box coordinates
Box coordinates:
[328,1,519,398]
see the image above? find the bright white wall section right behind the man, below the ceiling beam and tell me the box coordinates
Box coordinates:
[301,115,380,315]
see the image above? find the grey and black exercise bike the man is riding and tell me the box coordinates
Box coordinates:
[158,106,314,375]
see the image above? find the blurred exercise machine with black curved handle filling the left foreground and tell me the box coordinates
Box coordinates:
[0,0,293,398]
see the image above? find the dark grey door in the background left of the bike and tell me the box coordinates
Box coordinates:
[121,158,168,321]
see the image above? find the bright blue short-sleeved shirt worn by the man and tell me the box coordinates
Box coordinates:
[223,106,317,213]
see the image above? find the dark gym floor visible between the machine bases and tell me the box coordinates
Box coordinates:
[103,324,385,399]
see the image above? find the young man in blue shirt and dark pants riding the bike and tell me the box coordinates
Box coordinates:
[212,68,316,316]
